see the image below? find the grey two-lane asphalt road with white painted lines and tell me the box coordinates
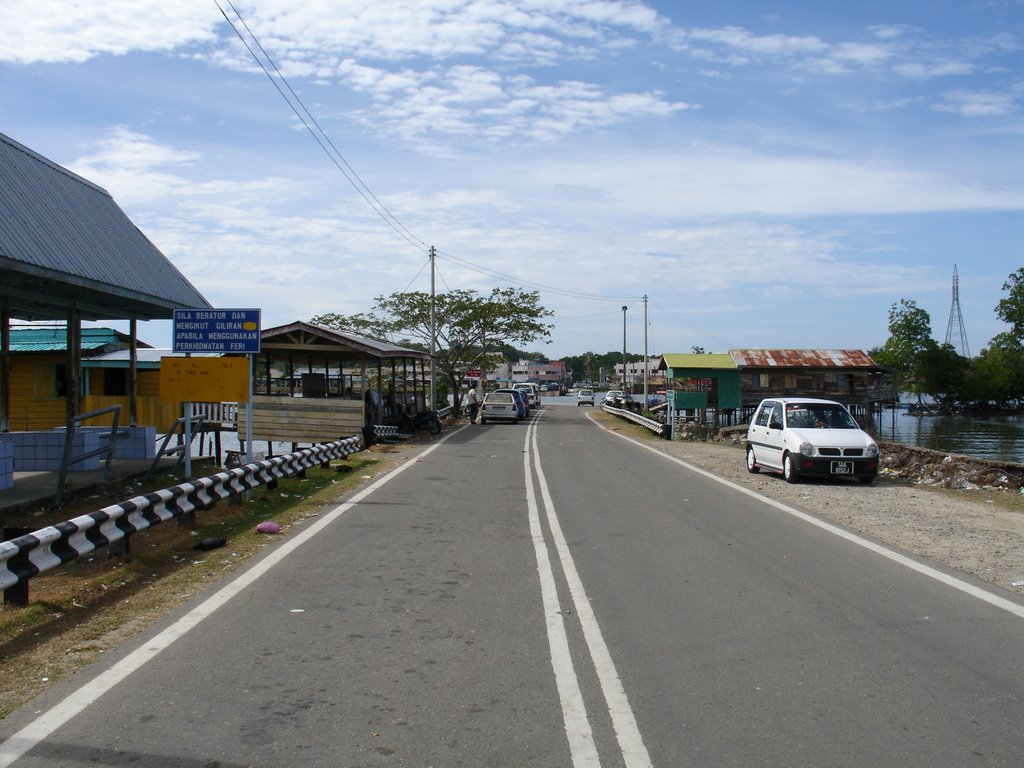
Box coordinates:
[0,407,1024,768]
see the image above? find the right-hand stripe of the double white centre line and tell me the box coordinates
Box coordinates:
[527,425,652,768]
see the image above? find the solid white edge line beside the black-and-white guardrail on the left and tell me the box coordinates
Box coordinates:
[0,432,455,768]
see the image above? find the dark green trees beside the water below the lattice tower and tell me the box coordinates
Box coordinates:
[868,267,1024,411]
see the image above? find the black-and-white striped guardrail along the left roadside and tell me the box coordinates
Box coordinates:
[0,436,361,605]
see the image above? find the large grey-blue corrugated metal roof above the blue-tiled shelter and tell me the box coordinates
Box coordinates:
[0,134,210,319]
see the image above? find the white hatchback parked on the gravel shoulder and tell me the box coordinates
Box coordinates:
[746,397,879,483]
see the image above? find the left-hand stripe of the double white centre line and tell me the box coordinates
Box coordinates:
[523,424,601,768]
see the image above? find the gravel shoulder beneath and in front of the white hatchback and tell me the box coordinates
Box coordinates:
[626,434,1024,596]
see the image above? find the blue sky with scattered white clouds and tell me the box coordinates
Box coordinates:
[0,0,1024,357]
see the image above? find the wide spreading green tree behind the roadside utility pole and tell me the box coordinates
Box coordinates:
[310,288,553,411]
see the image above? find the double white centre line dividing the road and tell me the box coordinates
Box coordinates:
[523,422,651,768]
